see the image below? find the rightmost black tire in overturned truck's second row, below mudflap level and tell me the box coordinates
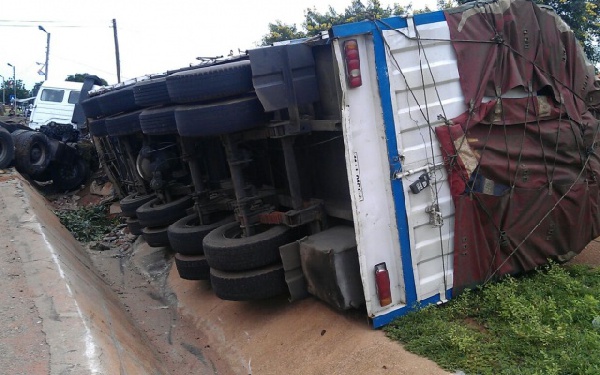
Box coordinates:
[175,95,266,137]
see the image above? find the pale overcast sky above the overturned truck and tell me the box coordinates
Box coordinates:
[0,0,435,90]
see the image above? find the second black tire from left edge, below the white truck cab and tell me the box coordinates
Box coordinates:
[12,131,52,177]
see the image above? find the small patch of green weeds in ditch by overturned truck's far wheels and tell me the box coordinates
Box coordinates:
[54,205,119,242]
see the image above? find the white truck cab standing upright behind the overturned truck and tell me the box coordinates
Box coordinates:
[29,81,83,129]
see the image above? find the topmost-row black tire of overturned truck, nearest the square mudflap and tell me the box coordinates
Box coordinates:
[167,60,254,103]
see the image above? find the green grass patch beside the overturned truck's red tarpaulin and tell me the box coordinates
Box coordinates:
[385,264,600,375]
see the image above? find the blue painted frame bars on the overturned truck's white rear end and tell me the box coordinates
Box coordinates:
[330,11,452,328]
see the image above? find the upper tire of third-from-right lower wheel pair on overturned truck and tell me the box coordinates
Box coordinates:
[135,195,194,227]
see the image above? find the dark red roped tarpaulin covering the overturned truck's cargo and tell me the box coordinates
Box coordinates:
[375,0,600,294]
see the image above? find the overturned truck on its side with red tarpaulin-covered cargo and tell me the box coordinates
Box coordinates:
[81,0,600,327]
